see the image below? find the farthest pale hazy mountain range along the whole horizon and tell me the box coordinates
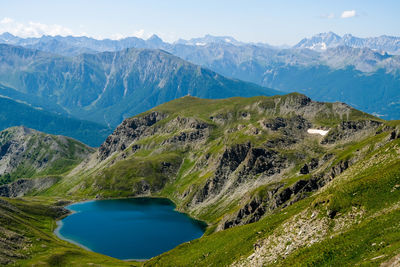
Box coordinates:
[0,32,400,56]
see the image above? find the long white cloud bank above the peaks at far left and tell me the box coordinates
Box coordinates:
[0,17,75,37]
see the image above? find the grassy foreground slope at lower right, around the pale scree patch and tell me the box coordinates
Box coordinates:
[147,126,400,266]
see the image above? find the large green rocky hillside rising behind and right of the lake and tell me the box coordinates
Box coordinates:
[0,93,400,266]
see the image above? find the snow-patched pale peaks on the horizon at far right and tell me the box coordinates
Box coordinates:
[294,32,400,55]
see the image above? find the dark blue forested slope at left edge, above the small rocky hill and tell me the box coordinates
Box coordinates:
[0,92,112,147]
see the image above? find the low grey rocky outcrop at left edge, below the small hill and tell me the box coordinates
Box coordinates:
[0,177,59,197]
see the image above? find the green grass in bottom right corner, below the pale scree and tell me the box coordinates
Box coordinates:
[276,210,400,266]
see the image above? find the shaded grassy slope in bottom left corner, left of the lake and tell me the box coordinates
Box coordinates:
[0,198,133,266]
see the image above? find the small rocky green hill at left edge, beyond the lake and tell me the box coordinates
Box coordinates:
[0,126,94,186]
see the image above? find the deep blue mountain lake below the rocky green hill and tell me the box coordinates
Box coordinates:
[56,198,205,260]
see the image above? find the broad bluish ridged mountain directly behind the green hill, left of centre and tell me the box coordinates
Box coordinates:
[0,43,279,126]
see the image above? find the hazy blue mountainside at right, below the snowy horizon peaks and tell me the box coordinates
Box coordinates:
[167,44,400,119]
